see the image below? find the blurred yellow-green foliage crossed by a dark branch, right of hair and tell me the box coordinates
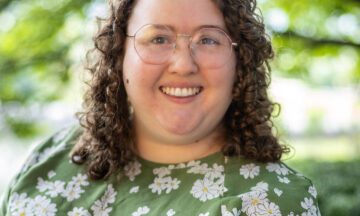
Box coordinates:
[261,0,360,86]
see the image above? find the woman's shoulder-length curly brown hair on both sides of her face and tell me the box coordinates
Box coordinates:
[72,0,288,179]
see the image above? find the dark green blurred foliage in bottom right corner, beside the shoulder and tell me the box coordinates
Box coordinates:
[292,160,360,216]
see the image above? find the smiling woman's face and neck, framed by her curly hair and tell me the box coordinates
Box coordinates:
[123,1,236,160]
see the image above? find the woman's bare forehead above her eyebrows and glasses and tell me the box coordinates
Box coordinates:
[128,0,225,33]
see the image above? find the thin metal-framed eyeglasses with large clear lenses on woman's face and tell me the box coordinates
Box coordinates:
[127,24,238,68]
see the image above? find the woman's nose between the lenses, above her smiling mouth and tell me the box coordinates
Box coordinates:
[169,35,199,75]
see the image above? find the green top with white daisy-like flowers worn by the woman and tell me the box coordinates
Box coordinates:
[0,128,320,216]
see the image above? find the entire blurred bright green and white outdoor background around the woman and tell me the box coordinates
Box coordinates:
[0,0,360,216]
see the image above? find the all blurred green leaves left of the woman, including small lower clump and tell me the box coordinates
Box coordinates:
[0,0,94,138]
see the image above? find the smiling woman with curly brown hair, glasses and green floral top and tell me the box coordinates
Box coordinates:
[1,0,320,216]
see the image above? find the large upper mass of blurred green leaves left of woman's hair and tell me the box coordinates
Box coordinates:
[0,0,90,104]
